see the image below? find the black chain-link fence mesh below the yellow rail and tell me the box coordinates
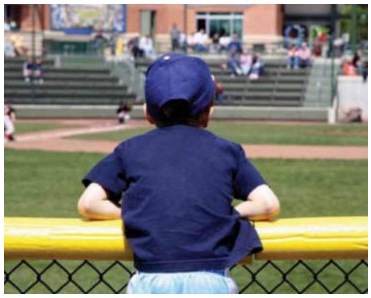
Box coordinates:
[4,260,368,294]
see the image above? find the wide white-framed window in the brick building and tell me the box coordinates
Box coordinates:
[196,12,243,38]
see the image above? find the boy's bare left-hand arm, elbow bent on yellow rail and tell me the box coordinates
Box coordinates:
[77,183,121,219]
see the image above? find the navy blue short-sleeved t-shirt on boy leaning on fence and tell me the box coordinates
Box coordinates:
[83,125,265,272]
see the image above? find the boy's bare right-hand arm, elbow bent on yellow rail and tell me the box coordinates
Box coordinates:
[235,184,280,221]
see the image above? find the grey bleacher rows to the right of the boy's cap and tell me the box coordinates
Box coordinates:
[136,59,309,107]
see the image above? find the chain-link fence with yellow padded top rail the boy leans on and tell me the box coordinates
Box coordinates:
[4,217,368,294]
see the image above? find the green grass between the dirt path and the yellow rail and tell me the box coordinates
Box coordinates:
[4,149,368,217]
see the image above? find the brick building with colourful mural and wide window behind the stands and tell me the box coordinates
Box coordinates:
[4,4,360,56]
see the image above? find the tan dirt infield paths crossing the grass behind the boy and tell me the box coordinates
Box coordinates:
[4,119,368,160]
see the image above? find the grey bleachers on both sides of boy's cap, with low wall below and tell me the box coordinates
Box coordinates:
[4,56,316,121]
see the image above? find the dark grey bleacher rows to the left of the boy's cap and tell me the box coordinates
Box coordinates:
[4,58,135,105]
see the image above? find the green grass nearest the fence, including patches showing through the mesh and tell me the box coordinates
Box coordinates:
[4,149,368,293]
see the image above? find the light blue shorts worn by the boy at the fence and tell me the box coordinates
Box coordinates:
[127,269,238,294]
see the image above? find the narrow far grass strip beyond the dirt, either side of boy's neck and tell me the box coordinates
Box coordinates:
[70,121,368,146]
